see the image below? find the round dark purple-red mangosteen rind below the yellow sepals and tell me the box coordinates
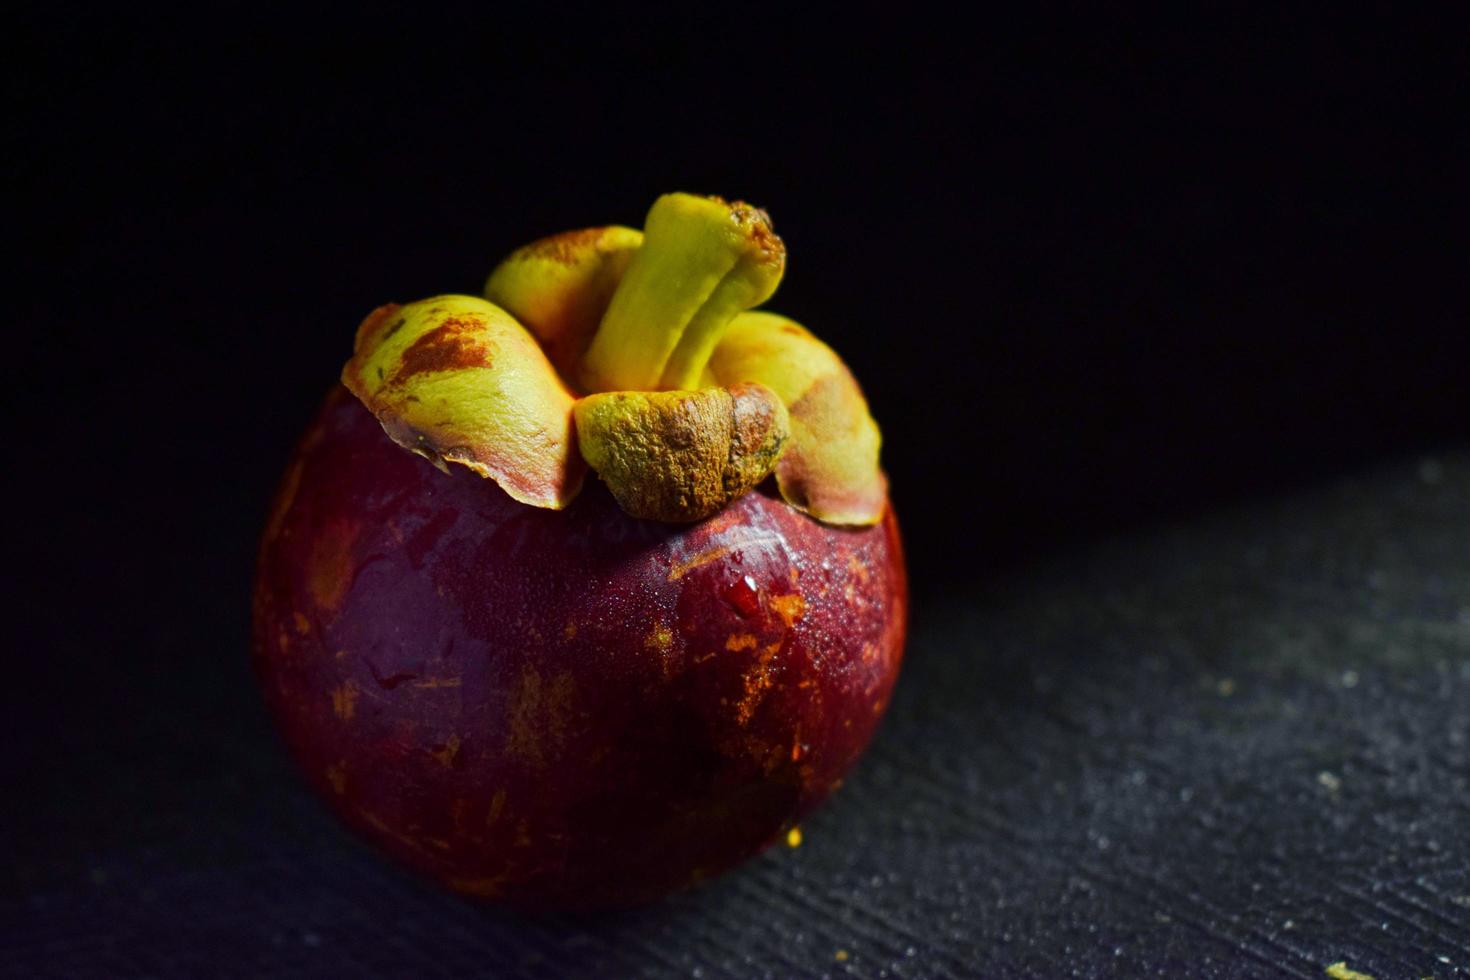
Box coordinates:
[254,389,907,908]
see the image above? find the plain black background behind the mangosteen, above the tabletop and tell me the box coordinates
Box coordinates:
[3,6,1470,976]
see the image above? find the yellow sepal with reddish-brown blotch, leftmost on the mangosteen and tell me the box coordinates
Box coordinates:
[343,295,587,510]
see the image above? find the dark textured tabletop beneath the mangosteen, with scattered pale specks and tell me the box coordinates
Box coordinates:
[0,454,1470,979]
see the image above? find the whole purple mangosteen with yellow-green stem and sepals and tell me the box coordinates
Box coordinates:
[253,195,907,908]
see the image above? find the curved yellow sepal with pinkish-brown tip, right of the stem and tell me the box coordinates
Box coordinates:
[710,311,888,526]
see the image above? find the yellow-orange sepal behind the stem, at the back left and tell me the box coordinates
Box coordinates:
[485,225,642,378]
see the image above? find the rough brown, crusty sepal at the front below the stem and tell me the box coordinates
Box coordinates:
[575,383,789,522]
